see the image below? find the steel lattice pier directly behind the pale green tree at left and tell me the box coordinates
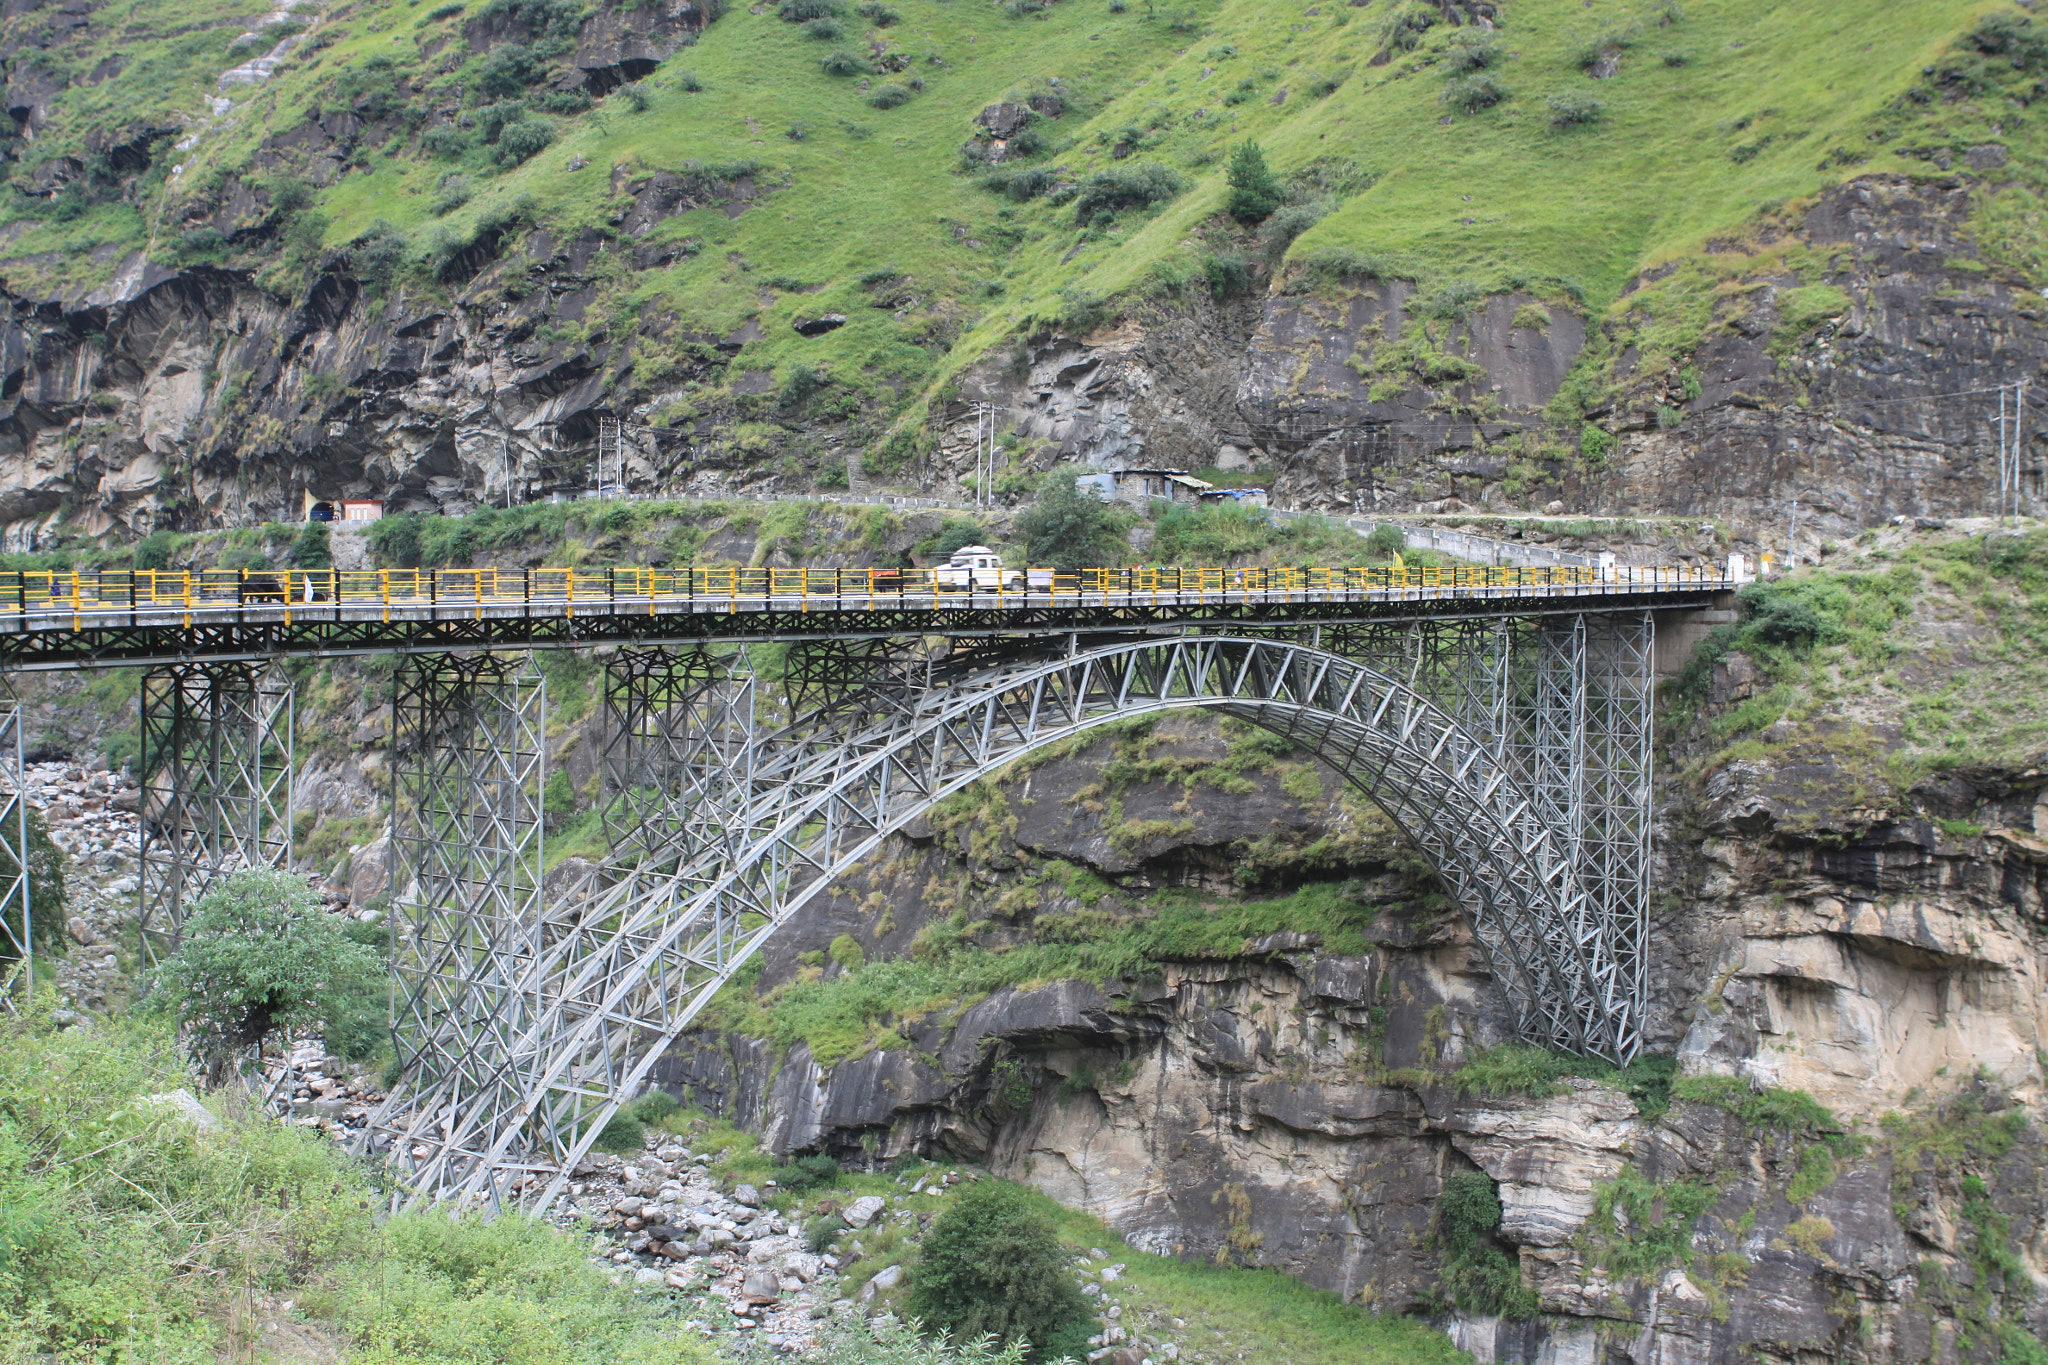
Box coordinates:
[141,663,293,954]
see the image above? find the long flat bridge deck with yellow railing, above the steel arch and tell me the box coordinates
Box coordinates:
[0,567,1739,669]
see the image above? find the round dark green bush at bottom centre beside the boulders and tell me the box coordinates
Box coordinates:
[909,1183,1094,1361]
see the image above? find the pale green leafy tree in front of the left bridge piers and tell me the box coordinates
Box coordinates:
[154,868,383,1085]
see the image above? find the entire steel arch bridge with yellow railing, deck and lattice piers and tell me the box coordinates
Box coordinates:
[0,571,1733,1207]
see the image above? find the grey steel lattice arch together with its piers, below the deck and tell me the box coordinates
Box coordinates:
[367,610,1653,1205]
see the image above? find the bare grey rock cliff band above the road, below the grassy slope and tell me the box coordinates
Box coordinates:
[0,167,2048,557]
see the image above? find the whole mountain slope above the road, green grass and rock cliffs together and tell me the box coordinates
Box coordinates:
[0,0,2048,548]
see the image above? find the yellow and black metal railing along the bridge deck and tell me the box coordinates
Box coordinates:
[0,565,1735,618]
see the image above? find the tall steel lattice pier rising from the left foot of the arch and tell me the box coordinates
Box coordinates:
[371,655,548,1189]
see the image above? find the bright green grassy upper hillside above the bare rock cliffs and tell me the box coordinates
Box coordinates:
[0,0,2048,446]
